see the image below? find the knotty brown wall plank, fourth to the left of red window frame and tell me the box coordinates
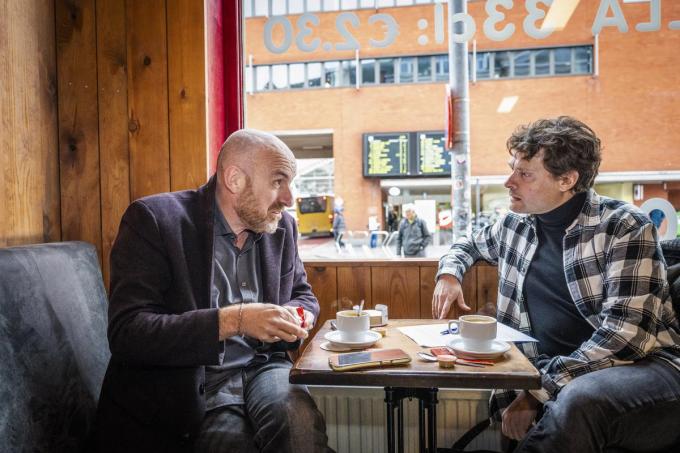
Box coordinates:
[55,0,102,259]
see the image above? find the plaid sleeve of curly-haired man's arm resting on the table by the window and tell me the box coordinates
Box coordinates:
[437,217,504,282]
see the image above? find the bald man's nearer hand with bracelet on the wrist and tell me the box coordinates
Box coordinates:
[219,303,308,343]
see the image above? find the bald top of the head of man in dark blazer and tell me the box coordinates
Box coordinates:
[217,129,295,174]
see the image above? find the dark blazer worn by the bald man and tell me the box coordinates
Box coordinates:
[95,176,319,451]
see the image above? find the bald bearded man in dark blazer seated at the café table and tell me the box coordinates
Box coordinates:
[95,130,329,452]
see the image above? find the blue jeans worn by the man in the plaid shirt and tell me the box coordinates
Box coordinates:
[515,358,680,453]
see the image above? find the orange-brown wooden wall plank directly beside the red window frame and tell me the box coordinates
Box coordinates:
[167,1,208,190]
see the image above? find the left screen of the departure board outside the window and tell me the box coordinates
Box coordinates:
[364,133,410,177]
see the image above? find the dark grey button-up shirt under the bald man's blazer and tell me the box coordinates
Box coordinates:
[205,206,262,410]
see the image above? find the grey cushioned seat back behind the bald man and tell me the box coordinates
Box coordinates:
[0,242,109,453]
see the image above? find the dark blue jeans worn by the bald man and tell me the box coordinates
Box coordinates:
[194,358,332,453]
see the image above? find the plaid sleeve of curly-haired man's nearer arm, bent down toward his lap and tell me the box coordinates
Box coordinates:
[541,222,668,395]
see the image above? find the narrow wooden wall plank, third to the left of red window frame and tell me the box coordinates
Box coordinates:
[97,0,130,282]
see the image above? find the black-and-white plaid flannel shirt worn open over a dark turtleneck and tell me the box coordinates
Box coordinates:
[437,190,680,421]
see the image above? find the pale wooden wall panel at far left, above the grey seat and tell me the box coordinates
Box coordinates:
[0,0,61,247]
